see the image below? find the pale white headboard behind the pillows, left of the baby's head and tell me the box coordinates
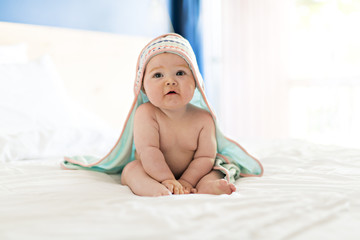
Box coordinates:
[0,22,150,129]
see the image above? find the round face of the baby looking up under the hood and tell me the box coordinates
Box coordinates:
[144,53,195,109]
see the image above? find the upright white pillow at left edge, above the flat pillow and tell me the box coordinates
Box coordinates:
[0,56,71,133]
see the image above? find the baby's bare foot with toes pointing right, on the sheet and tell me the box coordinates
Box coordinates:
[198,179,236,195]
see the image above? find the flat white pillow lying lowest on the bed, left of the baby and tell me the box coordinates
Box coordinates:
[0,126,119,162]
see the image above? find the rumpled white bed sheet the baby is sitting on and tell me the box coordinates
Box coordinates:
[0,141,360,240]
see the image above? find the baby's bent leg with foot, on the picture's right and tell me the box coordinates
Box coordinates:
[196,170,236,195]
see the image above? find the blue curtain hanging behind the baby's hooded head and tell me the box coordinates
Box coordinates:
[169,0,203,73]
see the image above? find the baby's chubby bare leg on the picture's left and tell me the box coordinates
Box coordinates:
[121,160,171,197]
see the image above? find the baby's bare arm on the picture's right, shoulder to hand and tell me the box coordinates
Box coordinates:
[179,114,217,187]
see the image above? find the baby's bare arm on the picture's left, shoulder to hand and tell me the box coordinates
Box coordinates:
[134,104,183,194]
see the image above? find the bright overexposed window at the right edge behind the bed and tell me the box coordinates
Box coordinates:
[287,0,360,147]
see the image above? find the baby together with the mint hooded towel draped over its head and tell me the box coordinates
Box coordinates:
[61,33,263,196]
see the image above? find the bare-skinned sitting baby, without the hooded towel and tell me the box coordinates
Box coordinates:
[121,52,236,196]
